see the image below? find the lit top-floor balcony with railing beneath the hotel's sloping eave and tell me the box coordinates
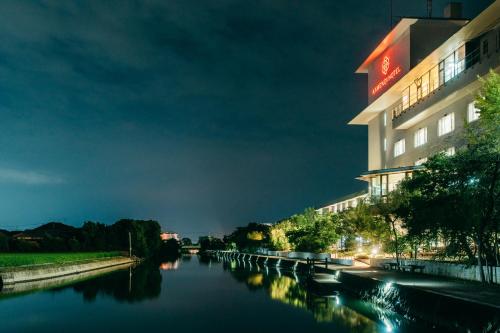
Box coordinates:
[392,44,480,119]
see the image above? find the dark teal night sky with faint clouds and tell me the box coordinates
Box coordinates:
[0,0,491,238]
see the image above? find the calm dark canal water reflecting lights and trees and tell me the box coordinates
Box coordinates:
[0,256,492,333]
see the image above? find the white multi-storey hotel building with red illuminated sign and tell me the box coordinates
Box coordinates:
[318,0,500,212]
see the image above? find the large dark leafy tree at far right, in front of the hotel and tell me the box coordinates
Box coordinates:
[399,72,500,282]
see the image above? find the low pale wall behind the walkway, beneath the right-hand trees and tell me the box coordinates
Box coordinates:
[370,259,500,284]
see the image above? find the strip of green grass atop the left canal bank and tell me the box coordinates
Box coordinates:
[0,251,122,267]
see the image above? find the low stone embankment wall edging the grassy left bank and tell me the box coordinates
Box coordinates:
[0,257,134,285]
